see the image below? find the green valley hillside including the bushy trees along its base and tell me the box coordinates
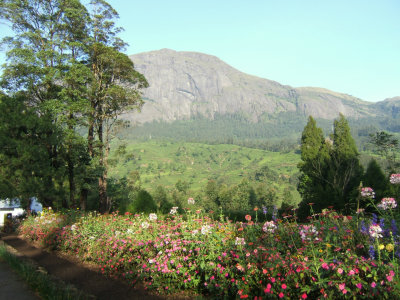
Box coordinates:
[110,141,300,213]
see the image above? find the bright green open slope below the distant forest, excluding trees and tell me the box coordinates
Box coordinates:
[110,141,300,192]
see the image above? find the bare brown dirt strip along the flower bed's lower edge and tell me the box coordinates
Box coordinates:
[2,234,166,300]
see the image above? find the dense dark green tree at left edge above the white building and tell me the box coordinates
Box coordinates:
[0,95,64,207]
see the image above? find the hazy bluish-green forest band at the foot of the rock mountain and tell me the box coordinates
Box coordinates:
[121,112,400,152]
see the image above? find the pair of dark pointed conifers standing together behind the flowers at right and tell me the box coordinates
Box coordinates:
[298,115,362,216]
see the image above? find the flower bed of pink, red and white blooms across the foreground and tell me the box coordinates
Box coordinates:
[19,174,400,299]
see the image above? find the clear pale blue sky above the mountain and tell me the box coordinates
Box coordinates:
[0,0,400,102]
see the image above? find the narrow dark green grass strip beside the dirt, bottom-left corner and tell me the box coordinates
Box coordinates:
[0,244,93,300]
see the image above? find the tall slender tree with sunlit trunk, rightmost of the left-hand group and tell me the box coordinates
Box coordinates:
[88,0,148,212]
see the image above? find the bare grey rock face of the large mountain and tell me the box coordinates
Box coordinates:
[124,49,382,123]
